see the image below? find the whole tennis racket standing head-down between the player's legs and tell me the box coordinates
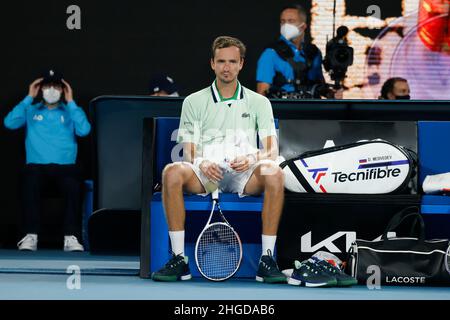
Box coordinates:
[195,190,242,281]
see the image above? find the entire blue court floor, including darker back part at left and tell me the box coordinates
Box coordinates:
[0,250,450,300]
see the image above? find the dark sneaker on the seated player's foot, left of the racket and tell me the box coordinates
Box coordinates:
[152,254,192,281]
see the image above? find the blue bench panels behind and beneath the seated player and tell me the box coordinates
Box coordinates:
[144,118,450,277]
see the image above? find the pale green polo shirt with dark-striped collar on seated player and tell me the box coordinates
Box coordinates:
[177,81,276,160]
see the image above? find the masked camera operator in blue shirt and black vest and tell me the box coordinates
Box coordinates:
[256,4,342,99]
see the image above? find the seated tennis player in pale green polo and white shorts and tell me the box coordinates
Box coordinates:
[152,36,286,283]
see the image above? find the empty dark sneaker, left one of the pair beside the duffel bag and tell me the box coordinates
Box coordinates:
[288,259,337,287]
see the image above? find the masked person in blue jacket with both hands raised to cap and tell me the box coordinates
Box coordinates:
[4,70,91,251]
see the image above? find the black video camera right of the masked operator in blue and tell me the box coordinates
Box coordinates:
[323,26,353,89]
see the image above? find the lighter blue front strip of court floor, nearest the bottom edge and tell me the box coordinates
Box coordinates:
[0,273,450,300]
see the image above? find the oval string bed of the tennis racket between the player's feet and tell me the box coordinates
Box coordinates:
[197,224,241,280]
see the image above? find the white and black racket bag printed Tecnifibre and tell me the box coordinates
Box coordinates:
[280,139,417,194]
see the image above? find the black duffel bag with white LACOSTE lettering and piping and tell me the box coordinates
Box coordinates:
[347,207,450,286]
